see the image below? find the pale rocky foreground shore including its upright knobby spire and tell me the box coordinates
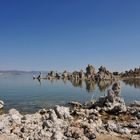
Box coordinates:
[0,83,140,140]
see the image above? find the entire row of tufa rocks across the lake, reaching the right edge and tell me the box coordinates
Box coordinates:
[33,64,140,85]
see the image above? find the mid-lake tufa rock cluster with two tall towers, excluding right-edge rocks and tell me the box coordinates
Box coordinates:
[33,64,115,81]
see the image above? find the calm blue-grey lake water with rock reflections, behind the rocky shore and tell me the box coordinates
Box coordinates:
[0,74,140,113]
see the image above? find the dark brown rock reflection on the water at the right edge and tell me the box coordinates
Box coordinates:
[123,79,140,89]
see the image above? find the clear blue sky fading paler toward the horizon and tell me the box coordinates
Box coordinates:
[0,0,140,71]
